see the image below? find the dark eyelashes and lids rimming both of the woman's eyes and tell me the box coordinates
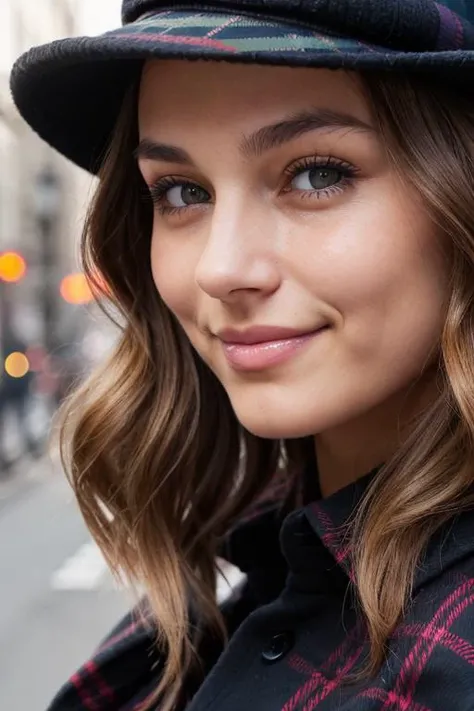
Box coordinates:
[148,156,359,216]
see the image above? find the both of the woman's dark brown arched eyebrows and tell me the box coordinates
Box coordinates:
[133,109,376,165]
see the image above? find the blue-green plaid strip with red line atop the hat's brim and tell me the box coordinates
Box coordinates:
[110,11,395,54]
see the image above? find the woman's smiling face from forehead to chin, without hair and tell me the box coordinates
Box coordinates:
[137,60,446,438]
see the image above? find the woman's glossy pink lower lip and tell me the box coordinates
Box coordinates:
[221,327,327,371]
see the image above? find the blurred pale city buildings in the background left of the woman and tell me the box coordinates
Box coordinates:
[0,0,121,462]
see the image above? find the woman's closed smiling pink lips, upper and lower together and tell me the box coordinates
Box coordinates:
[217,326,326,371]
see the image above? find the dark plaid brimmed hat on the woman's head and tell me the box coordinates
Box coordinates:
[11,0,474,173]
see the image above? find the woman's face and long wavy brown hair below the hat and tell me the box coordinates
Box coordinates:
[60,60,474,708]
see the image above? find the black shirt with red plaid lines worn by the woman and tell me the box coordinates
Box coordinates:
[49,468,474,711]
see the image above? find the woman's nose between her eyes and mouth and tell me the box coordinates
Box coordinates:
[196,202,280,301]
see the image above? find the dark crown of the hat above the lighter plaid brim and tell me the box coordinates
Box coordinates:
[123,0,474,51]
